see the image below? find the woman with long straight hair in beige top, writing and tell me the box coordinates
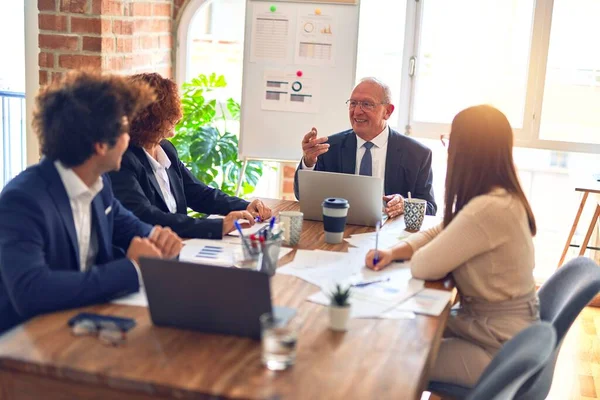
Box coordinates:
[366,105,539,386]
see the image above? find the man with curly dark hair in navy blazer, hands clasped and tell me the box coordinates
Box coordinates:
[0,71,182,332]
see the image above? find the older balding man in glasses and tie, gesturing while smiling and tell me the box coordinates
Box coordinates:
[294,78,437,218]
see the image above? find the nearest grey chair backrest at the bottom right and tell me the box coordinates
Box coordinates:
[467,322,556,400]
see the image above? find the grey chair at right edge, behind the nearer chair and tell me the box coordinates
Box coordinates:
[515,257,600,400]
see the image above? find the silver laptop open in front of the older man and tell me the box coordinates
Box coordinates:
[298,170,387,226]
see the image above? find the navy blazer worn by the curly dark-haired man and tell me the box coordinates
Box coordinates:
[0,159,152,332]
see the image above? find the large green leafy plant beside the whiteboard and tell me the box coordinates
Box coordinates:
[171,73,263,196]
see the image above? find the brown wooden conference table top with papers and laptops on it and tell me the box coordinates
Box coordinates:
[0,199,453,399]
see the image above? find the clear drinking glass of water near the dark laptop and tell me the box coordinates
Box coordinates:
[260,313,301,371]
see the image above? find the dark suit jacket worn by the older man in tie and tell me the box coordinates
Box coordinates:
[294,128,437,215]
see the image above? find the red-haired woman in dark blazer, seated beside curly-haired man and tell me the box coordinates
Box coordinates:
[110,73,271,239]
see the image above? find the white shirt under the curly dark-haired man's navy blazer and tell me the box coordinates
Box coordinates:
[54,161,104,271]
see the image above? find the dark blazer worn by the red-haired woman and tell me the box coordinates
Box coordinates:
[109,140,249,239]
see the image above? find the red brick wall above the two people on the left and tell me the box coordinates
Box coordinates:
[38,0,174,85]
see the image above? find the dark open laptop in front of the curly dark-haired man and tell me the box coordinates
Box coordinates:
[140,258,295,339]
